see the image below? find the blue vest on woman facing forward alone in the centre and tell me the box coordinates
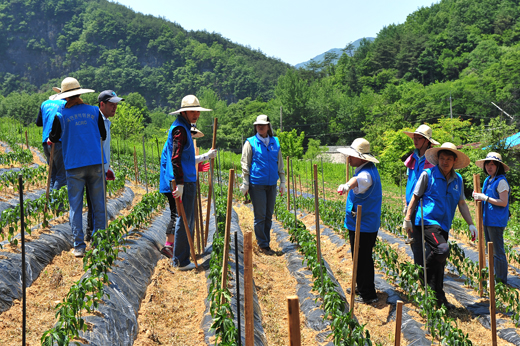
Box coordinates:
[247,135,280,185]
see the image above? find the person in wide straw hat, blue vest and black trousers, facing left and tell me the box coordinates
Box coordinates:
[338,138,383,304]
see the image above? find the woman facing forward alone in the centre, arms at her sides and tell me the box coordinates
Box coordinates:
[240,114,285,256]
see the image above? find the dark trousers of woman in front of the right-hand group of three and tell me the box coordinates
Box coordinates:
[424,225,450,304]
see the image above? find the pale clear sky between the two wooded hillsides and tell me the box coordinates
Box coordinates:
[117,0,438,65]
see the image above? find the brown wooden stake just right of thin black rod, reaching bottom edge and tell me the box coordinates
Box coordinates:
[244,231,255,346]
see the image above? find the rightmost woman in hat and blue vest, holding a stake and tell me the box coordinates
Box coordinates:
[473,152,510,284]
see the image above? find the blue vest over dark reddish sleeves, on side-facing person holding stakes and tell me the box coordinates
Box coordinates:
[159,116,197,193]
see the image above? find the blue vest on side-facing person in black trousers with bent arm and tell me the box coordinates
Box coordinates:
[344,162,383,233]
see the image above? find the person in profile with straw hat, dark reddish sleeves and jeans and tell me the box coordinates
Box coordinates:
[159,95,217,271]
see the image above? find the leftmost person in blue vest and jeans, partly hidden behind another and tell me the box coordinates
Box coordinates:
[36,94,67,191]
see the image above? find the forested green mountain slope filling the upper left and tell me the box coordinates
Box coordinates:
[0,0,290,108]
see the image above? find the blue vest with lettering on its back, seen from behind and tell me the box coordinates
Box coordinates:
[56,104,106,169]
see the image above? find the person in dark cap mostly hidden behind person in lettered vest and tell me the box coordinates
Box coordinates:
[85,90,125,241]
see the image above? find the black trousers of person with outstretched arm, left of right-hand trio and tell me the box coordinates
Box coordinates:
[348,230,377,300]
